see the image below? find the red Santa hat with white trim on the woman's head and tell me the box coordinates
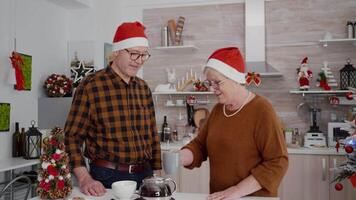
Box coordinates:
[203,47,246,84]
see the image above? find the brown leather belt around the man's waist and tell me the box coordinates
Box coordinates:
[91,159,147,174]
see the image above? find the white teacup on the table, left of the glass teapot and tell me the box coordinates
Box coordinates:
[111,180,137,200]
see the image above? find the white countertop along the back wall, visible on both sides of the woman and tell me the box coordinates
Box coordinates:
[161,141,346,156]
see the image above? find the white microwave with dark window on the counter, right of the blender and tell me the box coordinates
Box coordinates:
[328,122,350,147]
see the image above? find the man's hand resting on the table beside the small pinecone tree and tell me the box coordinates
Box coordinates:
[79,175,106,196]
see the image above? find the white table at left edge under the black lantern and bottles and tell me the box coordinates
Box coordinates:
[0,157,40,200]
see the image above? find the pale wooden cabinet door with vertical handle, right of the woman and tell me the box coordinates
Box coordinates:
[279,154,329,200]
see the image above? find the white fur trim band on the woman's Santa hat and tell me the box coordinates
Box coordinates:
[203,58,246,84]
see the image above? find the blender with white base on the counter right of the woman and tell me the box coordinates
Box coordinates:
[304,108,326,148]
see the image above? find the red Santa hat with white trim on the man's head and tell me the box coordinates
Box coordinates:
[112,22,148,51]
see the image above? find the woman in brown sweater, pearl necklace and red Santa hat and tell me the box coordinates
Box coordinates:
[179,47,288,199]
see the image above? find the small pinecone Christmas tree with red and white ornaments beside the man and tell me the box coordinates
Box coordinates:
[37,127,73,199]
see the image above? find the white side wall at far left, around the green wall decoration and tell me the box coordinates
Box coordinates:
[0,0,69,159]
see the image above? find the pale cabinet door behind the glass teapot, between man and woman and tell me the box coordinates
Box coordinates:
[179,161,210,194]
